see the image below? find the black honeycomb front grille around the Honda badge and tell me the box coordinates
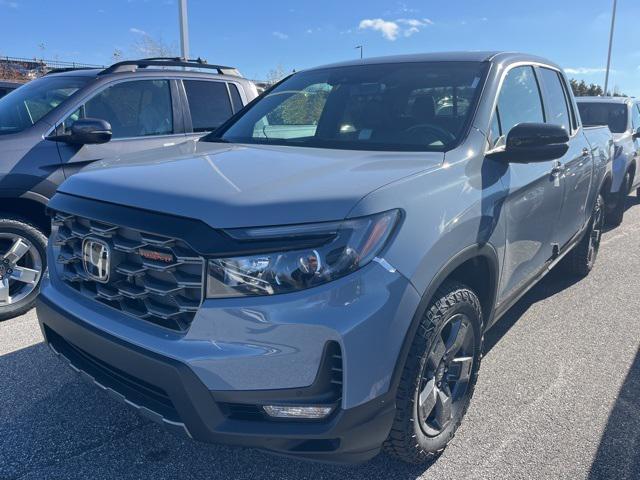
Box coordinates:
[52,212,204,331]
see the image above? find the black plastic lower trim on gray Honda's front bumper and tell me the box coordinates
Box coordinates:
[37,292,395,463]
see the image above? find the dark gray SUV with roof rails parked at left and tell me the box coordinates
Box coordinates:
[0,58,258,319]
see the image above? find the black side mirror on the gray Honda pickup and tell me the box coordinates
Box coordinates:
[489,123,569,163]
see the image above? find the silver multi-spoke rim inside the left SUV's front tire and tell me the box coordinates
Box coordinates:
[0,233,42,308]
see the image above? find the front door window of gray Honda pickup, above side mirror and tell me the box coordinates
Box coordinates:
[498,67,544,135]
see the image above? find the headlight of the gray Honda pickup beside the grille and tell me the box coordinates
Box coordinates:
[207,210,400,298]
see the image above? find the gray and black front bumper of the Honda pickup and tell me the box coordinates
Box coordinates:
[37,264,419,463]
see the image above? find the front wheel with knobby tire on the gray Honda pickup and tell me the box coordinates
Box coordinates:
[384,282,484,463]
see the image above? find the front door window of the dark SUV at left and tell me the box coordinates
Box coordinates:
[76,80,173,138]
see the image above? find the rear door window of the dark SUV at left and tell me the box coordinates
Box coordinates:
[184,80,233,132]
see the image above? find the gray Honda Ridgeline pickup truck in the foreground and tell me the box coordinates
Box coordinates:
[38,52,612,463]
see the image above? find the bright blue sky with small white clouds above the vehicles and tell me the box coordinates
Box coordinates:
[0,0,640,96]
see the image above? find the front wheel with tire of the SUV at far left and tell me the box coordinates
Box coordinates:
[0,218,47,320]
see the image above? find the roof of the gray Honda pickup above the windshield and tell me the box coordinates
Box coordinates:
[311,51,560,70]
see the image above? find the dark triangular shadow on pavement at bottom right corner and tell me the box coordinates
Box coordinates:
[588,349,640,480]
